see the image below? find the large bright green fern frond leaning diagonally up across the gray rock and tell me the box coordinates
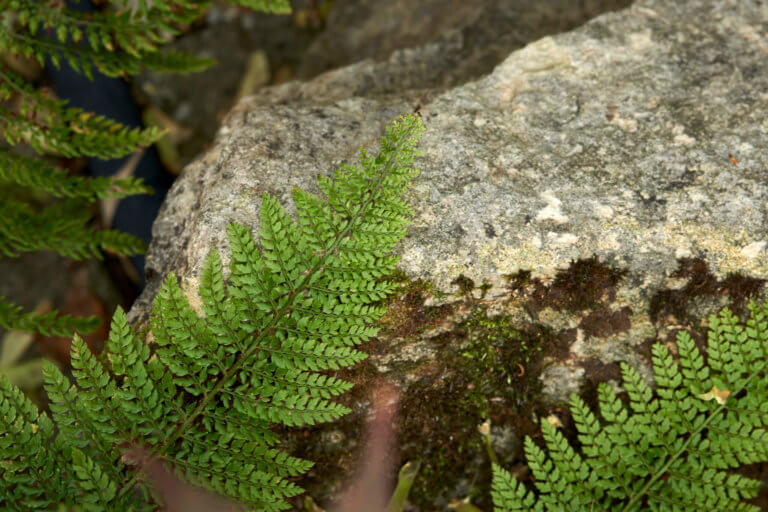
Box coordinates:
[0,115,423,511]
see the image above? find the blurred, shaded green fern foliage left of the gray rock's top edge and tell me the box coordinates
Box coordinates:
[0,0,290,336]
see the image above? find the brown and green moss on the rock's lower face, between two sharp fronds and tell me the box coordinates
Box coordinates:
[295,258,652,512]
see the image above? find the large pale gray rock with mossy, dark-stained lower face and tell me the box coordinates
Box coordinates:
[131,0,768,510]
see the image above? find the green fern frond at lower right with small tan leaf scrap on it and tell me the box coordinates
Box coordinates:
[493,302,768,512]
